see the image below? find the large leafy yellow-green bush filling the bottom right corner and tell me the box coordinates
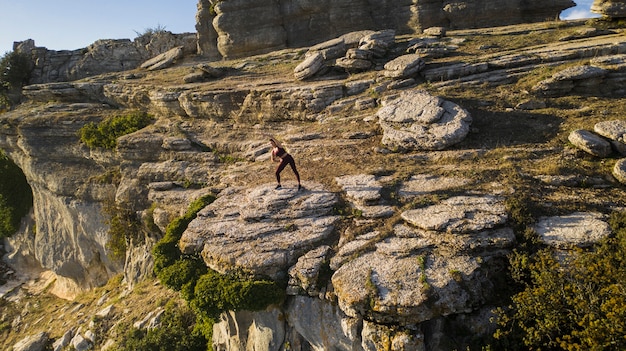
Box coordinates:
[494,213,626,351]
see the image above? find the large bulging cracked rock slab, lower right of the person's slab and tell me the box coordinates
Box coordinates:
[331,225,515,325]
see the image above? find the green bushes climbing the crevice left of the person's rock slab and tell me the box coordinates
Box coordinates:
[152,195,285,346]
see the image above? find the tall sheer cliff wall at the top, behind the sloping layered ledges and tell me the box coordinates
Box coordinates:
[202,0,575,58]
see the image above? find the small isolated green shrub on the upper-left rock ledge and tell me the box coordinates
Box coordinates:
[78,111,152,149]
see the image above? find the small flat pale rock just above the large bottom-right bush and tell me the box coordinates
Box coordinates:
[535,212,611,248]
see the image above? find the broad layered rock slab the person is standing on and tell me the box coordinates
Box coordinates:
[179,184,338,280]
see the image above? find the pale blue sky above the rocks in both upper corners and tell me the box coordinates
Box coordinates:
[0,0,593,56]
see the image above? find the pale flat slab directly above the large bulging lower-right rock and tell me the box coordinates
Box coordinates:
[402,195,508,233]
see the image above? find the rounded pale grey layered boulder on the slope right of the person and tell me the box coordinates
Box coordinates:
[376,90,472,150]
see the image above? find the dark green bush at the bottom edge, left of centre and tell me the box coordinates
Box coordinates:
[116,303,207,351]
